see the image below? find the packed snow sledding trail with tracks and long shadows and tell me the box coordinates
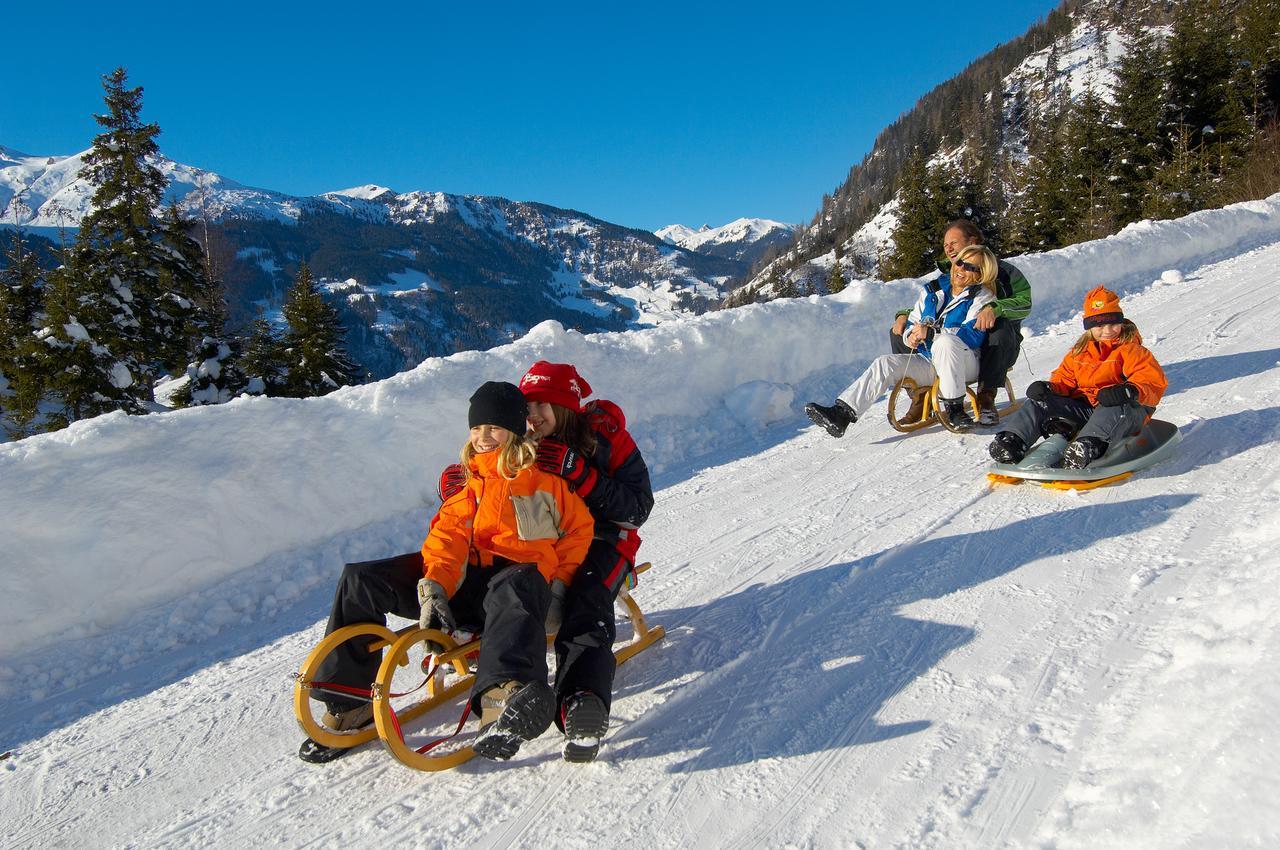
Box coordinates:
[0,218,1280,847]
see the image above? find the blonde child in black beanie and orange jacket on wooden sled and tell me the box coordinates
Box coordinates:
[303,381,593,759]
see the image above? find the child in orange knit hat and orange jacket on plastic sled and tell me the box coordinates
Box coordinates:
[988,287,1169,470]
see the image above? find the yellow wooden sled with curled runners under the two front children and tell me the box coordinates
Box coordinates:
[293,562,666,771]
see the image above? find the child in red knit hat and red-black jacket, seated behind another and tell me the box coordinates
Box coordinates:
[440,360,653,762]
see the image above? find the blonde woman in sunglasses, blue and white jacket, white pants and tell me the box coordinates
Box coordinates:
[804,245,1000,437]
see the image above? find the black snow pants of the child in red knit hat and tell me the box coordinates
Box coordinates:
[556,540,634,725]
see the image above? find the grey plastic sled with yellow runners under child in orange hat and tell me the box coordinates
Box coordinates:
[987,419,1183,490]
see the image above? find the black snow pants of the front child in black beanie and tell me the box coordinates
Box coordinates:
[316,552,550,710]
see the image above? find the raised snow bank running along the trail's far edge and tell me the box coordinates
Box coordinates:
[0,195,1280,662]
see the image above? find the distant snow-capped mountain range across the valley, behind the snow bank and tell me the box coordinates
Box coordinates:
[0,147,786,378]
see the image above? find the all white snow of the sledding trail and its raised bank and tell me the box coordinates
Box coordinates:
[0,195,1280,849]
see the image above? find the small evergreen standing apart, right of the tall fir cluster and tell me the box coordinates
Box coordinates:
[284,262,357,398]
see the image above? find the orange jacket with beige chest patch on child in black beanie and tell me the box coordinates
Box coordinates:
[422,452,595,597]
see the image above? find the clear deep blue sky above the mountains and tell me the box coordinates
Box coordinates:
[0,0,1057,229]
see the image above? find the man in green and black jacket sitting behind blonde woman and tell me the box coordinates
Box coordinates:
[890,219,1032,425]
